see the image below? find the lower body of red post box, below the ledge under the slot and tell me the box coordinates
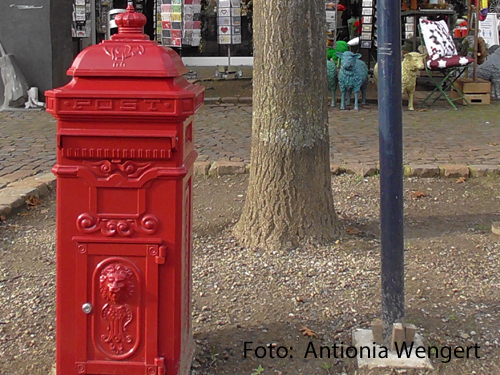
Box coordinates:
[55,165,194,375]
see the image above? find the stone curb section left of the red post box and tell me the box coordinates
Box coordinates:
[0,173,56,217]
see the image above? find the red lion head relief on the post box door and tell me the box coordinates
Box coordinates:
[99,263,135,304]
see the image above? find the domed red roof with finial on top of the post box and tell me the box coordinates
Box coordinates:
[68,5,187,77]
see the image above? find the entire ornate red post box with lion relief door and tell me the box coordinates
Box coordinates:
[46,6,204,375]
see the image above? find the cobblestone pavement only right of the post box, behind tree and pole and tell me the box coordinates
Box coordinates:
[195,103,500,165]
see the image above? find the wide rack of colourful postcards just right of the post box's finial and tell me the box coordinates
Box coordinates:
[156,0,201,48]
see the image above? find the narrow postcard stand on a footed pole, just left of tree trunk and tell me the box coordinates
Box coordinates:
[214,0,243,79]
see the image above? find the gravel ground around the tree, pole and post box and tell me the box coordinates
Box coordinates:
[0,175,500,375]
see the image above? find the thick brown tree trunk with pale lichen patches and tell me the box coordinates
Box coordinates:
[235,0,339,253]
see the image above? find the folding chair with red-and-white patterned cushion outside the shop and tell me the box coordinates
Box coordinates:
[419,19,474,110]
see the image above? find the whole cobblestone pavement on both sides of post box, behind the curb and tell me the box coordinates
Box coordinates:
[0,102,500,187]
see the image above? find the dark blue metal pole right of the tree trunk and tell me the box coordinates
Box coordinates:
[377,0,405,342]
